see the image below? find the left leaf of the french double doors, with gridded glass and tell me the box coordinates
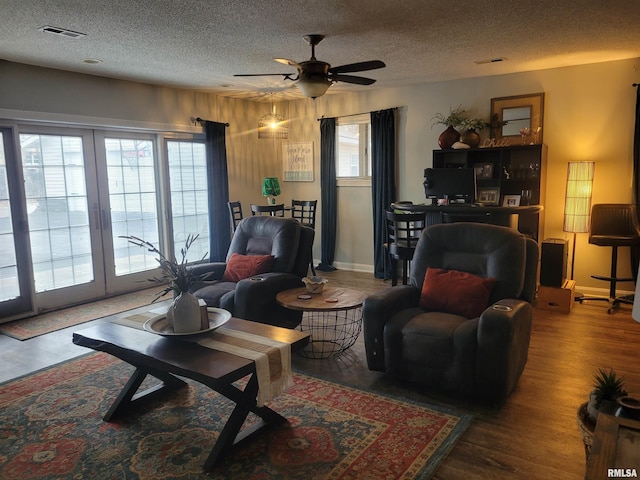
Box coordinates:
[19,129,104,308]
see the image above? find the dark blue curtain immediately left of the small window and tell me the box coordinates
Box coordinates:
[317,118,338,272]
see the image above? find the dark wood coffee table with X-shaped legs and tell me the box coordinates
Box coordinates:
[73,318,309,470]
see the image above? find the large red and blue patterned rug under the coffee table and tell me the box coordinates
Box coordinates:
[0,353,471,480]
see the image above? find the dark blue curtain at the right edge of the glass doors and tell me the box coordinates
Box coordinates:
[204,120,231,262]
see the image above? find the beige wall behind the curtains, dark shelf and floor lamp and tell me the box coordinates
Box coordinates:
[0,59,640,291]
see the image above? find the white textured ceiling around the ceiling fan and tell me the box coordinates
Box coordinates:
[0,0,640,99]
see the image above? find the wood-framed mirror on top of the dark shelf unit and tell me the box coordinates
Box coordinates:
[490,92,544,145]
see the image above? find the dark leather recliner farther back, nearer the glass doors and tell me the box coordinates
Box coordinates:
[191,216,314,328]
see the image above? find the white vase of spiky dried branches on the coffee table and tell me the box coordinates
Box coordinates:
[120,235,208,333]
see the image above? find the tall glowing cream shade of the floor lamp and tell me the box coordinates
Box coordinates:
[562,162,596,233]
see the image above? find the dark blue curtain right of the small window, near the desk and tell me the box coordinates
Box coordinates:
[371,108,396,278]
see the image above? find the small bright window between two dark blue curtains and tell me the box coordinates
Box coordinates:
[336,114,371,182]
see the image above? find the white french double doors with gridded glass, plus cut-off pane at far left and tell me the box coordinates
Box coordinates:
[0,127,165,317]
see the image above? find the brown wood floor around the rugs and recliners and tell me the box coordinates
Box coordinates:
[0,271,640,480]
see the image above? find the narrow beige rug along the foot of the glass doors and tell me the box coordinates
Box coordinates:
[0,287,159,340]
